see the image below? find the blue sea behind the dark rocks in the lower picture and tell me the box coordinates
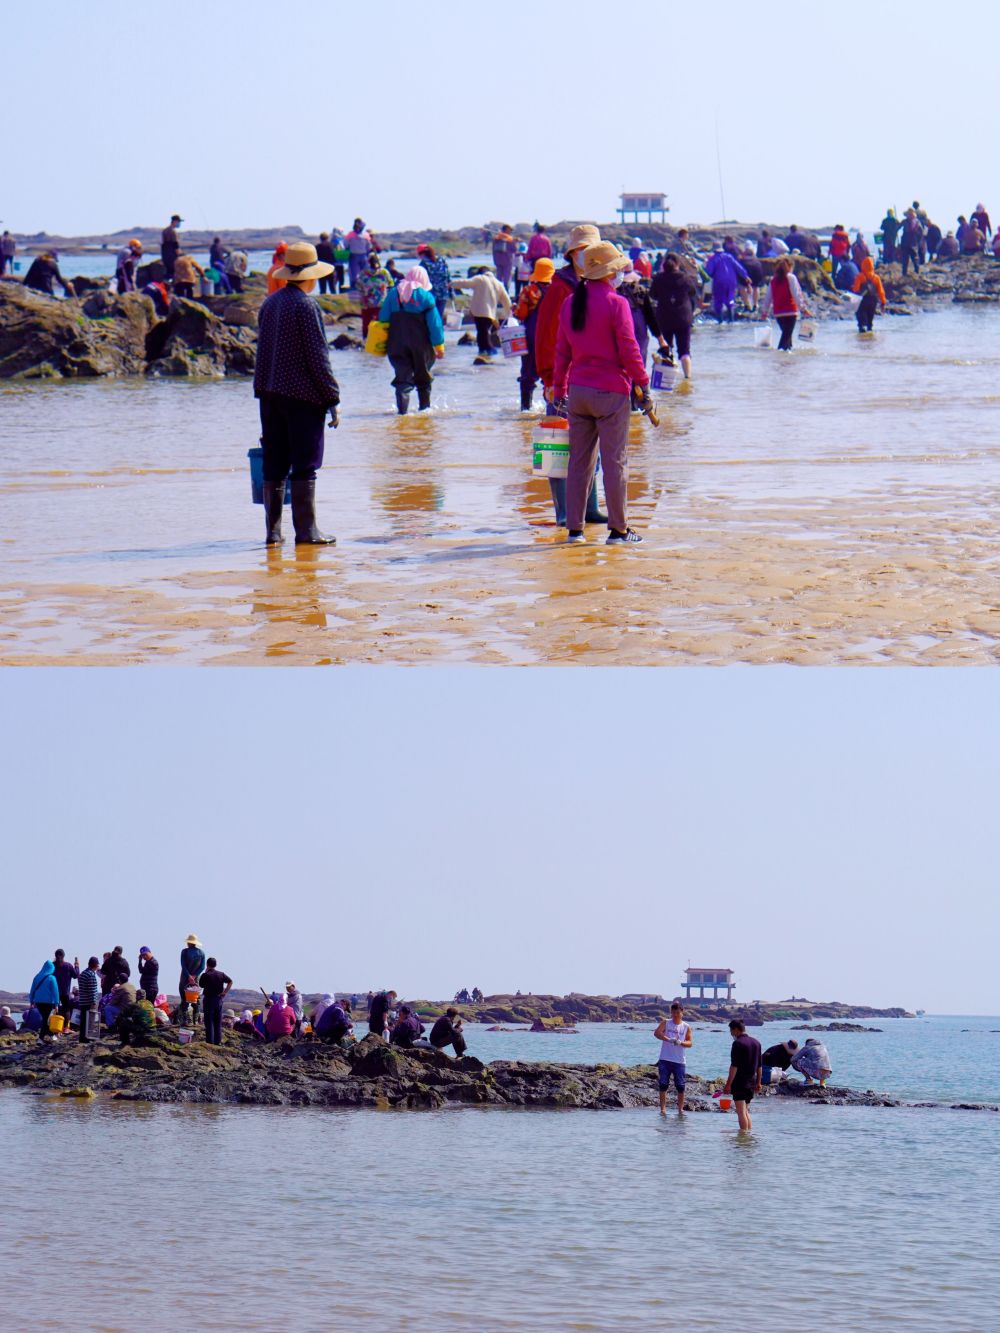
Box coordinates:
[467,1014,1000,1103]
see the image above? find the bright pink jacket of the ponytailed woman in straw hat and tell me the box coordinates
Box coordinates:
[552,283,649,399]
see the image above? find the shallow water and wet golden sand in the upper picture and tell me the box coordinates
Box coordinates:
[0,308,1000,664]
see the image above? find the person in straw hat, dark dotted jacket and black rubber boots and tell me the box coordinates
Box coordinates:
[253,241,340,547]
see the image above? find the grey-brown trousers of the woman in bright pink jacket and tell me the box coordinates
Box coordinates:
[565,384,632,532]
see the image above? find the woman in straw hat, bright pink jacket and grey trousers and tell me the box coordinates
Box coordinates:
[552,241,649,547]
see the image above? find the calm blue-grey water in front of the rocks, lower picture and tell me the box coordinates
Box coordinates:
[0,1093,1000,1333]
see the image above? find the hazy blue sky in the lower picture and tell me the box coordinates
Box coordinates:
[0,668,1000,1014]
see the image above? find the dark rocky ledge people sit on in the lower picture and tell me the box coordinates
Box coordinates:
[0,1032,1000,1112]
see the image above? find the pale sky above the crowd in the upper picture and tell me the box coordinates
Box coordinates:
[0,0,1000,235]
